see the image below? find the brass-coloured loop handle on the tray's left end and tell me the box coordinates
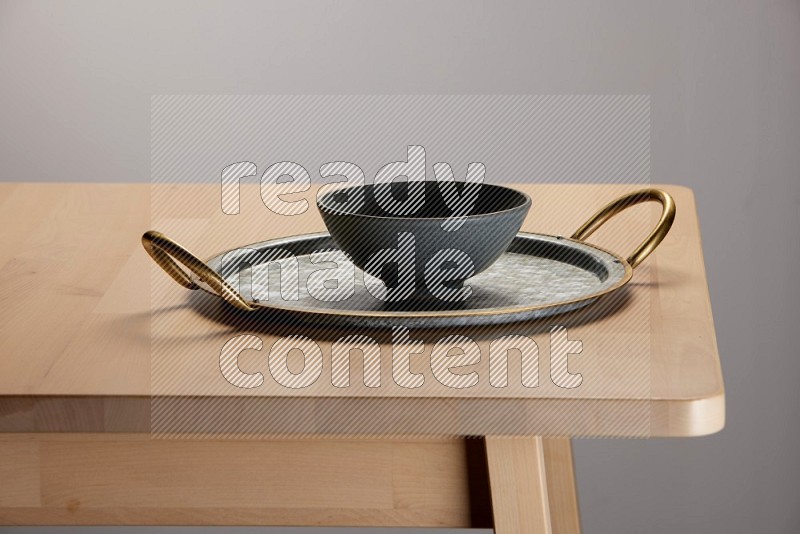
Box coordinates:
[142,230,255,311]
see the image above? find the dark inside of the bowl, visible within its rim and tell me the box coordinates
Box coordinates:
[318,181,529,219]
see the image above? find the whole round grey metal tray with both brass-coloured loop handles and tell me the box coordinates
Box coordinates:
[142,189,675,327]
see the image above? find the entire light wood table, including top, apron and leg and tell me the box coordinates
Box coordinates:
[0,184,724,533]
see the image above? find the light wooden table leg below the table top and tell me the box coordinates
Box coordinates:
[486,437,580,534]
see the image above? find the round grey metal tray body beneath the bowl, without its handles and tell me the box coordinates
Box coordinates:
[194,233,631,327]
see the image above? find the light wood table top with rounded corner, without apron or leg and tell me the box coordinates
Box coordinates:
[0,183,724,437]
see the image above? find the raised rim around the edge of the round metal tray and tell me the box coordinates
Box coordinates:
[191,232,633,320]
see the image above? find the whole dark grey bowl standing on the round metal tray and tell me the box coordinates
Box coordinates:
[317,181,531,301]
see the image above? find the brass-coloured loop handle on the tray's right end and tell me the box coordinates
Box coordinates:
[572,189,675,268]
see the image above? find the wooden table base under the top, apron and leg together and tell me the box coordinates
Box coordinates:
[0,433,580,534]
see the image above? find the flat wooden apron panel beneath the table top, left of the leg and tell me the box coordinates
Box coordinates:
[0,434,488,527]
